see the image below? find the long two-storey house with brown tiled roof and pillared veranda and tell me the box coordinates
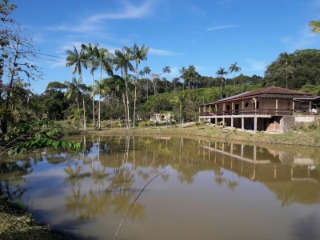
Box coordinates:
[199,86,320,133]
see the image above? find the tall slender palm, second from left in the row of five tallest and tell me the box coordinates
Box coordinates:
[82,43,99,127]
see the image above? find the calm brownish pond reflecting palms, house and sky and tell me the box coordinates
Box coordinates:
[0,136,320,240]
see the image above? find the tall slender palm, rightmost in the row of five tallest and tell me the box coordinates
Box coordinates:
[132,43,149,127]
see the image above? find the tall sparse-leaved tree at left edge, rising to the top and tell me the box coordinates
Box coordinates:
[0,0,41,134]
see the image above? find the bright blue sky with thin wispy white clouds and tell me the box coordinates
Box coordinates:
[11,0,320,93]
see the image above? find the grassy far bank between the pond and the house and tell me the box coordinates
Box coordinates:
[80,125,320,147]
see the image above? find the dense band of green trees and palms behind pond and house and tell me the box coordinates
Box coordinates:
[0,0,320,133]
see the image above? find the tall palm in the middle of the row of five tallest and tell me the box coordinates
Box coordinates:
[96,48,113,129]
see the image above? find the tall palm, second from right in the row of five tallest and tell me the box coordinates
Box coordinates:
[114,47,134,128]
